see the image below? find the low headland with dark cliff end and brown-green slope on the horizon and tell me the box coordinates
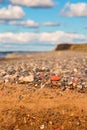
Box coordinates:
[55,43,87,51]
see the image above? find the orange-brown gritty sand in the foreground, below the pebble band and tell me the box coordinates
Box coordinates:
[0,84,87,130]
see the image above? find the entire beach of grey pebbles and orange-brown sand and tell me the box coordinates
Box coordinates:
[0,51,87,130]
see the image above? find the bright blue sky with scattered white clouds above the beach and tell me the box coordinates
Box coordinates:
[0,0,87,51]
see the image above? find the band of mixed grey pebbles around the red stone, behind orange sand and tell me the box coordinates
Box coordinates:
[0,52,87,91]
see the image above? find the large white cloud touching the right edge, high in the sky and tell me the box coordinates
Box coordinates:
[61,2,87,17]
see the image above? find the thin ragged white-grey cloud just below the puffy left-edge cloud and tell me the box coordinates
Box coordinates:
[8,20,40,28]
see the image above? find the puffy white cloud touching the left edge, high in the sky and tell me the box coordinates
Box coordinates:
[0,5,25,20]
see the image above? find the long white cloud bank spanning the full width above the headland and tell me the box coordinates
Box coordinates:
[0,31,87,44]
